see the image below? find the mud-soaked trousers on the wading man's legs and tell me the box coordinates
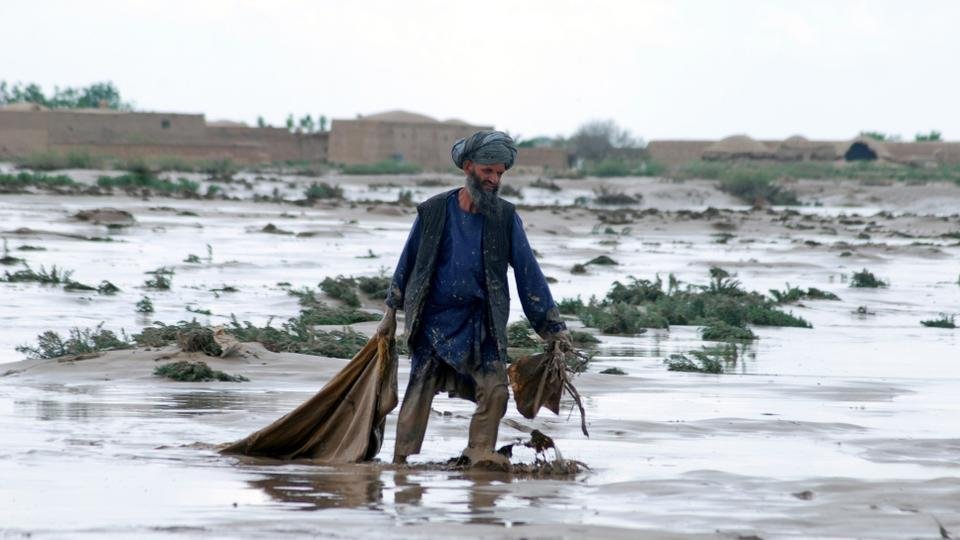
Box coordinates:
[393,362,510,461]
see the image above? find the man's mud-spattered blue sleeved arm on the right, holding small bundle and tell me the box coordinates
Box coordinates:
[510,215,567,342]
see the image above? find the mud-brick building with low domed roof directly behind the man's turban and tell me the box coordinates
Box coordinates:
[328,111,568,170]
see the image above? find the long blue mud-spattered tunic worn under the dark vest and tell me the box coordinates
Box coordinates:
[386,191,563,373]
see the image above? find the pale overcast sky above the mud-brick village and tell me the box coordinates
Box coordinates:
[0,0,960,140]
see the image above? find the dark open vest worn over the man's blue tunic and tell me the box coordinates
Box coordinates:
[403,188,516,362]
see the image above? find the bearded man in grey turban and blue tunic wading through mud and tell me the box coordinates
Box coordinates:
[377,131,570,465]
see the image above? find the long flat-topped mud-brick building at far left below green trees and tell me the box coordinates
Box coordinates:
[0,104,327,163]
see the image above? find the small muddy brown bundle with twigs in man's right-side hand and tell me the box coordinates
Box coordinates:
[507,342,590,437]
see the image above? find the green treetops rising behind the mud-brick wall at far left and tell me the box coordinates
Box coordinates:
[0,81,133,111]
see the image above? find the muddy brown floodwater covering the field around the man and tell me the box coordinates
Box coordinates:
[0,172,960,539]
